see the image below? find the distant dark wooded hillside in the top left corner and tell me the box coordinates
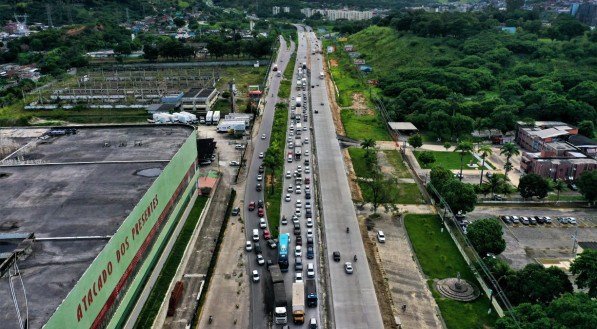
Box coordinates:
[0,0,197,26]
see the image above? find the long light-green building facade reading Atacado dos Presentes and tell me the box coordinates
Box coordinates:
[44,132,197,328]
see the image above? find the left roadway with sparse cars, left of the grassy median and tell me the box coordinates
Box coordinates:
[243,38,295,329]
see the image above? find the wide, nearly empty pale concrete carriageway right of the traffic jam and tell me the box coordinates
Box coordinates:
[297,27,383,329]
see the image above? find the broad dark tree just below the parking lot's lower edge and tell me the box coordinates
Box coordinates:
[501,263,572,305]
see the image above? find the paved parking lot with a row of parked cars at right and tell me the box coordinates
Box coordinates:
[466,206,597,269]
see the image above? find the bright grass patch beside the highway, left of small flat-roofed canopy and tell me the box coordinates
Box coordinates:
[340,110,392,141]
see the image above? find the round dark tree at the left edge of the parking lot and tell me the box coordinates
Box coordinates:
[466,218,506,257]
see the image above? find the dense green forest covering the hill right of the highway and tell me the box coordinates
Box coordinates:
[340,11,597,138]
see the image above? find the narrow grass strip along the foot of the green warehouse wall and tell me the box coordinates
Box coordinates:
[135,196,208,328]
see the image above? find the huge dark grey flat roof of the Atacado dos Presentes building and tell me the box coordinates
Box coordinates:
[0,125,192,329]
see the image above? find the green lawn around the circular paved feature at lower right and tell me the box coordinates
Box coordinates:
[404,214,497,329]
